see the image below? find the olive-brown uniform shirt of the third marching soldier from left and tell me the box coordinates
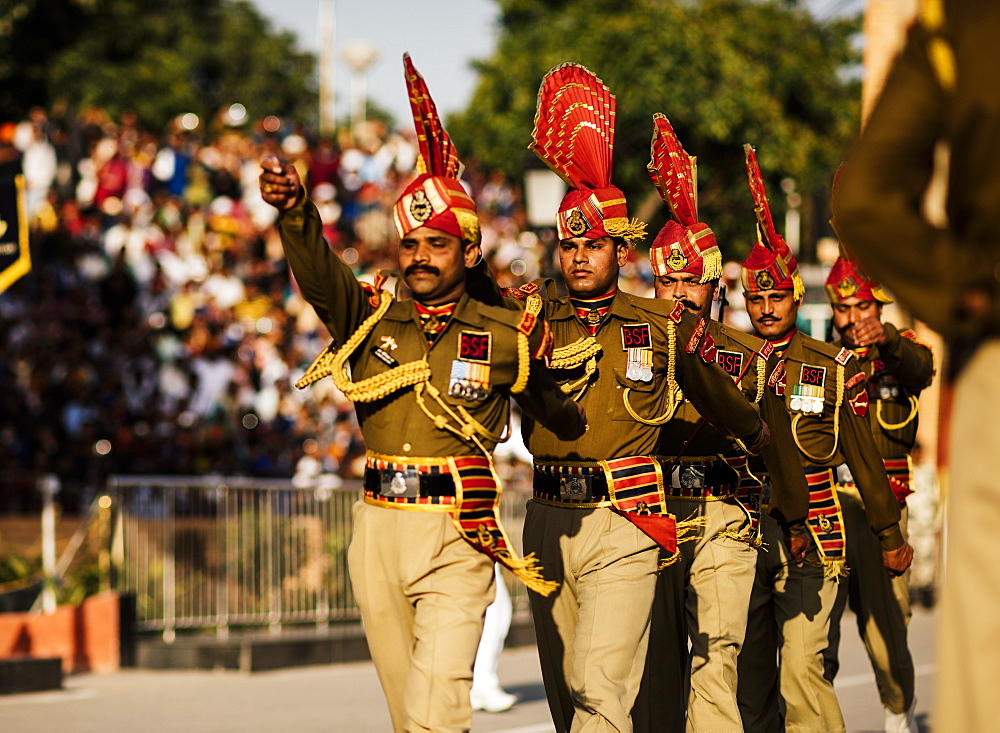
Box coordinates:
[657,321,809,535]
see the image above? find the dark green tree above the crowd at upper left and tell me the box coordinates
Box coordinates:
[0,0,315,129]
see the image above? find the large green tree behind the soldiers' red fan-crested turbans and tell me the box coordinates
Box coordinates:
[449,0,860,256]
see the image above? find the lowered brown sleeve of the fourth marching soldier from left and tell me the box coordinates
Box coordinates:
[839,359,905,551]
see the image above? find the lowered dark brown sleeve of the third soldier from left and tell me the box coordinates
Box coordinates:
[760,380,809,537]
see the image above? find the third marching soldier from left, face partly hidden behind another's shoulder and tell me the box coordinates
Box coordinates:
[634,114,809,731]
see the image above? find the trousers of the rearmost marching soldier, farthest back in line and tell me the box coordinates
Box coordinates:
[826,487,914,713]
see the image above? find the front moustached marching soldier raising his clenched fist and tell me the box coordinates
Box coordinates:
[260,56,585,731]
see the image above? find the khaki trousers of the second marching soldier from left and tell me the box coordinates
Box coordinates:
[524,501,659,733]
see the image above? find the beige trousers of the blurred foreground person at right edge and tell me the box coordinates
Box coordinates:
[933,339,1000,733]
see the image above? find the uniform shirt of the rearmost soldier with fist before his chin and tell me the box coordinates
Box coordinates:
[835,323,934,458]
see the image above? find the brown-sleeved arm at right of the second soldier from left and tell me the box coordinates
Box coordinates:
[666,312,769,452]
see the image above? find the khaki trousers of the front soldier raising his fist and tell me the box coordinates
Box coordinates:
[347,501,493,733]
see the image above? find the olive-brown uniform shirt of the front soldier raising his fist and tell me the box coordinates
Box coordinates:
[278,201,580,457]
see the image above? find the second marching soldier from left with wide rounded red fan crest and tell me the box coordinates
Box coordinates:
[472,64,769,733]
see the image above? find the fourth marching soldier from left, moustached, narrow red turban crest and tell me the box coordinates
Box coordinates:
[739,145,913,732]
